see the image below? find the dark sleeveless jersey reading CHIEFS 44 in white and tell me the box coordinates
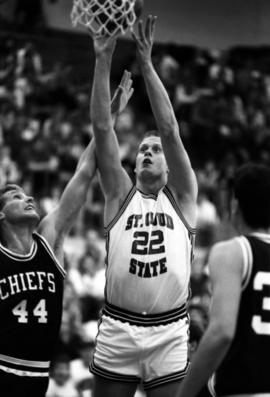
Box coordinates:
[0,233,65,376]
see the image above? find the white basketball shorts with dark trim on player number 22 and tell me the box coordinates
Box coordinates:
[90,306,189,390]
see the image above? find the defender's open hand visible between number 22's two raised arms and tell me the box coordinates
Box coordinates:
[111,70,134,115]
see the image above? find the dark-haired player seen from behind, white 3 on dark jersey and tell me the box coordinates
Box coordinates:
[178,164,270,397]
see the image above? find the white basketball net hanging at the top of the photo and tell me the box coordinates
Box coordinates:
[70,0,136,37]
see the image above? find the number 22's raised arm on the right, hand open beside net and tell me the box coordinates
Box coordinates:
[133,15,197,225]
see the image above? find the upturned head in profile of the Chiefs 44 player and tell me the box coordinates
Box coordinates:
[1,188,40,224]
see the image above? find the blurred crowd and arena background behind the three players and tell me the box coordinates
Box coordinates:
[0,0,270,397]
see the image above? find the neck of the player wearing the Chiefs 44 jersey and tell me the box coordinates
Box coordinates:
[1,226,33,255]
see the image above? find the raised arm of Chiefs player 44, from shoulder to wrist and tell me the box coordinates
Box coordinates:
[38,140,96,261]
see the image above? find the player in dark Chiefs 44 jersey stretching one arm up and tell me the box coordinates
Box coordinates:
[0,138,96,397]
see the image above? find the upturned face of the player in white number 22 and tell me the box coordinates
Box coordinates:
[135,136,168,179]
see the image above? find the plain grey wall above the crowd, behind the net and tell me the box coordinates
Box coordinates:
[0,0,270,48]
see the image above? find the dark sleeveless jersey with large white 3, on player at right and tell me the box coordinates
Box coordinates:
[215,234,270,396]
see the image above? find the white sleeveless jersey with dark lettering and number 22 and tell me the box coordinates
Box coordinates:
[105,186,195,315]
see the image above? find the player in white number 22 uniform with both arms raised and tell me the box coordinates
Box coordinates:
[91,16,197,397]
